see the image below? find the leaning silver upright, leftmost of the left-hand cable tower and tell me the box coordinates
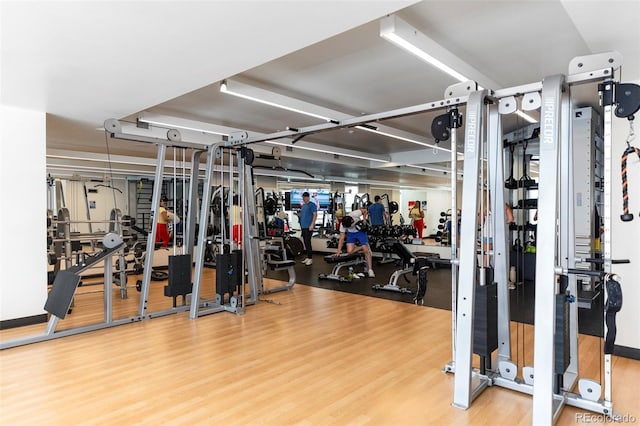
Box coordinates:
[138,143,167,317]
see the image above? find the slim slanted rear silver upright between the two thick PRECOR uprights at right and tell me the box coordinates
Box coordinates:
[488,104,511,361]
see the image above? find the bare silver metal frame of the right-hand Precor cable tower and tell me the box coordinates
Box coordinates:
[445,52,632,424]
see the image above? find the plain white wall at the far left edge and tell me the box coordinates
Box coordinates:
[0,105,47,321]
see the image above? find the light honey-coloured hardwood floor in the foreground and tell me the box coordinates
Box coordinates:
[0,272,640,425]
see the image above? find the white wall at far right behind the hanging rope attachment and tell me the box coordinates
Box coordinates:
[611,80,640,349]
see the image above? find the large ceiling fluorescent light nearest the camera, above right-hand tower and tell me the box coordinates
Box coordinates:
[380,15,499,90]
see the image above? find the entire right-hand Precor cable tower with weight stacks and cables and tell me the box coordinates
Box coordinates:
[444,52,640,425]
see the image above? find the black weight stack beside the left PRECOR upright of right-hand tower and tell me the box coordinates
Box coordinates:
[473,283,498,357]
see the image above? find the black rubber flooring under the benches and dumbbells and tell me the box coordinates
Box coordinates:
[266,254,603,336]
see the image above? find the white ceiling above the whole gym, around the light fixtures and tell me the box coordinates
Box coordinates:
[0,0,640,186]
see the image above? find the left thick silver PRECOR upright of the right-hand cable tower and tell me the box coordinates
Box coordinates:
[453,90,487,409]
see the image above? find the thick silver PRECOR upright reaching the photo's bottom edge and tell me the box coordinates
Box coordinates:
[533,75,564,425]
